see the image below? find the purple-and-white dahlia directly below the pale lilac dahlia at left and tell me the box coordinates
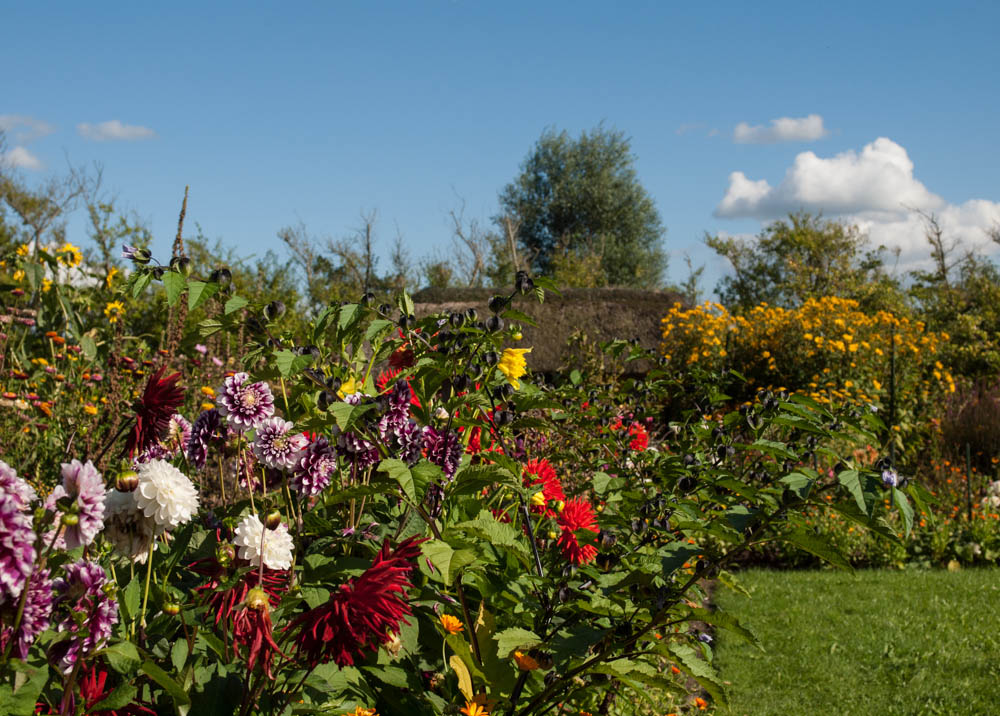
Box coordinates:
[51,560,118,674]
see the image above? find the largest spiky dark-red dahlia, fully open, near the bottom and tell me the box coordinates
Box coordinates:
[288,537,423,667]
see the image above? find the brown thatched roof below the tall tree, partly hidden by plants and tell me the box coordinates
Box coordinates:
[413,288,682,373]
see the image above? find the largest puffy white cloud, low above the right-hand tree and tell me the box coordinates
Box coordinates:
[715,137,1000,267]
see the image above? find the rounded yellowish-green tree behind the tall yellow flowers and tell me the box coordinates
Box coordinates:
[705,212,903,309]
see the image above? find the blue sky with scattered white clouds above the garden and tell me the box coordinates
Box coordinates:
[0,0,1000,289]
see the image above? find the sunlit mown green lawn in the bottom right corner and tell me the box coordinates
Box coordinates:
[715,569,1000,716]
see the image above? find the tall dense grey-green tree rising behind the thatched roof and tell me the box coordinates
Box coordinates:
[496,126,667,288]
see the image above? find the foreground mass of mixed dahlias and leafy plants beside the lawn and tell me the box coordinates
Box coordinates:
[0,250,924,716]
